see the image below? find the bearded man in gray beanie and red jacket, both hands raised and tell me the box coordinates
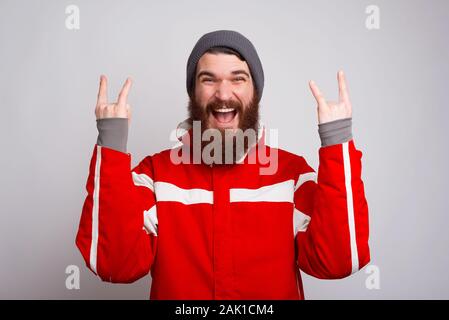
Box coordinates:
[76,30,370,300]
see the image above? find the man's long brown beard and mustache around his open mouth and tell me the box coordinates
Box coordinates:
[188,91,259,164]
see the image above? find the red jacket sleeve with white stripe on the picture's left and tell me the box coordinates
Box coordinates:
[76,144,157,283]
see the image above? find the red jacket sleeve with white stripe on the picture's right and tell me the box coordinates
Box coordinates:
[294,139,370,279]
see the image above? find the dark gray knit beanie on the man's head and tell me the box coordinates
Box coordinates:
[186,30,264,100]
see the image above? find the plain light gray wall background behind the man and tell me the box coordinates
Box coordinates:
[0,0,449,299]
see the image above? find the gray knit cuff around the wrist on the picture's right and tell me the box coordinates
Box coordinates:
[318,118,352,147]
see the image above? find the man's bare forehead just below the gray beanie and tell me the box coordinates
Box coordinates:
[196,53,249,75]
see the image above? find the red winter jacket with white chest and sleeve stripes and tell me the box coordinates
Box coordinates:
[76,124,370,299]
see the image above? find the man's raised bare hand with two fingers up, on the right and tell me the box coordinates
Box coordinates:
[309,71,352,124]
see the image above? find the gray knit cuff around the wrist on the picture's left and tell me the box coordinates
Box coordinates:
[97,118,128,153]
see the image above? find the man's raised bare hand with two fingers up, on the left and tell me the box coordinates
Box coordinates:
[95,75,131,124]
